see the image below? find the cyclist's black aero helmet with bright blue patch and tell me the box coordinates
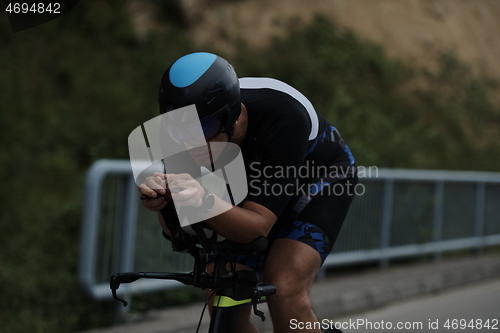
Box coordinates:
[159,52,241,140]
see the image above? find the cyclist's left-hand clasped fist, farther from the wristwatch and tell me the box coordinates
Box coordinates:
[139,172,168,212]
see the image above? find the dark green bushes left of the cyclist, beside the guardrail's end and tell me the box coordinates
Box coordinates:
[0,1,193,333]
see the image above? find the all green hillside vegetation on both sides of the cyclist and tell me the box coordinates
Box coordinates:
[0,0,500,333]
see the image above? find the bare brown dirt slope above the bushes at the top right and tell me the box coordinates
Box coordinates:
[180,0,500,79]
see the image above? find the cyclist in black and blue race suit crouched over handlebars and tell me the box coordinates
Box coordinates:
[139,53,357,333]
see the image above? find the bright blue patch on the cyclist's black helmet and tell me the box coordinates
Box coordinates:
[169,52,217,88]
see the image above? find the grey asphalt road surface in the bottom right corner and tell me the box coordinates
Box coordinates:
[330,279,500,333]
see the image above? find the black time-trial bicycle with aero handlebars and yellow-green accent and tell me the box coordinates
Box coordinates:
[110,204,276,333]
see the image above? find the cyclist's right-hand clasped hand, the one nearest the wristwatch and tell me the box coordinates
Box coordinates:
[167,173,205,208]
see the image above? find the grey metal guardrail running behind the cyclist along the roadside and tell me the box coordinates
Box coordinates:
[79,160,500,300]
